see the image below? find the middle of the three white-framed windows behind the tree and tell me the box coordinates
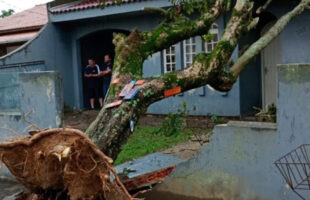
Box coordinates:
[183,37,196,67]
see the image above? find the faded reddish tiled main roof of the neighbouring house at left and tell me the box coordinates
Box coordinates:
[0,4,48,34]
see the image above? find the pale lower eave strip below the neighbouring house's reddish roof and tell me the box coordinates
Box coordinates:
[0,31,38,45]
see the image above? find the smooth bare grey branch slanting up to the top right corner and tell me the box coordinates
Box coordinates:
[230,0,310,80]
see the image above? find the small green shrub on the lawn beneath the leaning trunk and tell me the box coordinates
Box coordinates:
[154,102,187,137]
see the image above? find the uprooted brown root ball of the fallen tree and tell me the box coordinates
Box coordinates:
[0,129,136,200]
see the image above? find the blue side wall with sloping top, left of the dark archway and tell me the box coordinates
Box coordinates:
[0,23,75,107]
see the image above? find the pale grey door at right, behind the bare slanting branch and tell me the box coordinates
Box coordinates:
[261,22,281,107]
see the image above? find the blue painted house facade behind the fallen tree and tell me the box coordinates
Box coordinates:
[0,0,310,116]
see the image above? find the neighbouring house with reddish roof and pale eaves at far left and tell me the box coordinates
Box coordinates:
[0,4,48,57]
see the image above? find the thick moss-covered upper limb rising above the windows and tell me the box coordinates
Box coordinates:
[110,0,231,77]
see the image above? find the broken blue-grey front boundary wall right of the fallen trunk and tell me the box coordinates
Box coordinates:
[157,64,310,200]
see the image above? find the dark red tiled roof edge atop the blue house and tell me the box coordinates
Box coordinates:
[50,0,147,14]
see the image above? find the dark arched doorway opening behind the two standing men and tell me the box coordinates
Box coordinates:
[80,30,129,108]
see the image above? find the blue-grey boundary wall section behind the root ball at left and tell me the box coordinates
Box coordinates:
[0,72,63,176]
